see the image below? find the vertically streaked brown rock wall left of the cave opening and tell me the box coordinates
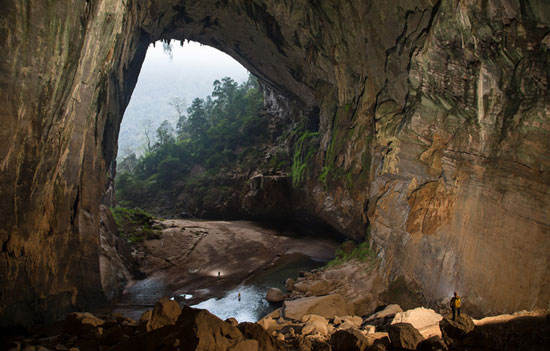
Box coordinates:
[0,0,147,325]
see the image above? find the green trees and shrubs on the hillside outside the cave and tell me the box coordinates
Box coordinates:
[116,76,288,209]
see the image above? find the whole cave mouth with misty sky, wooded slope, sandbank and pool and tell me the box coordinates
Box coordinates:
[108,42,338,321]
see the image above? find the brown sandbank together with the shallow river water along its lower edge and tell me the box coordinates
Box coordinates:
[114,220,338,322]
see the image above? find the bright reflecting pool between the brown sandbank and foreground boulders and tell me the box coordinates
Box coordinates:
[192,254,326,322]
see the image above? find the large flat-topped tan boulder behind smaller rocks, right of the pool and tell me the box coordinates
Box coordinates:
[283,294,348,320]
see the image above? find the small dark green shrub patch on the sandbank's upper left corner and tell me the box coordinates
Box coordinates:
[111,207,159,244]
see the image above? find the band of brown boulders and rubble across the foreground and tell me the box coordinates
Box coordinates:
[0,294,550,351]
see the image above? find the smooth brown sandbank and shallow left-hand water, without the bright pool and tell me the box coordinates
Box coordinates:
[109,219,337,318]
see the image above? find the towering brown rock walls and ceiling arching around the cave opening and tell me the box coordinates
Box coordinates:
[0,0,550,325]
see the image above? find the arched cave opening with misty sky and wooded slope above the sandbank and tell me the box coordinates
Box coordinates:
[115,41,296,219]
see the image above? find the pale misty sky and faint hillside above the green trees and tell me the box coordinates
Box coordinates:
[118,42,252,161]
